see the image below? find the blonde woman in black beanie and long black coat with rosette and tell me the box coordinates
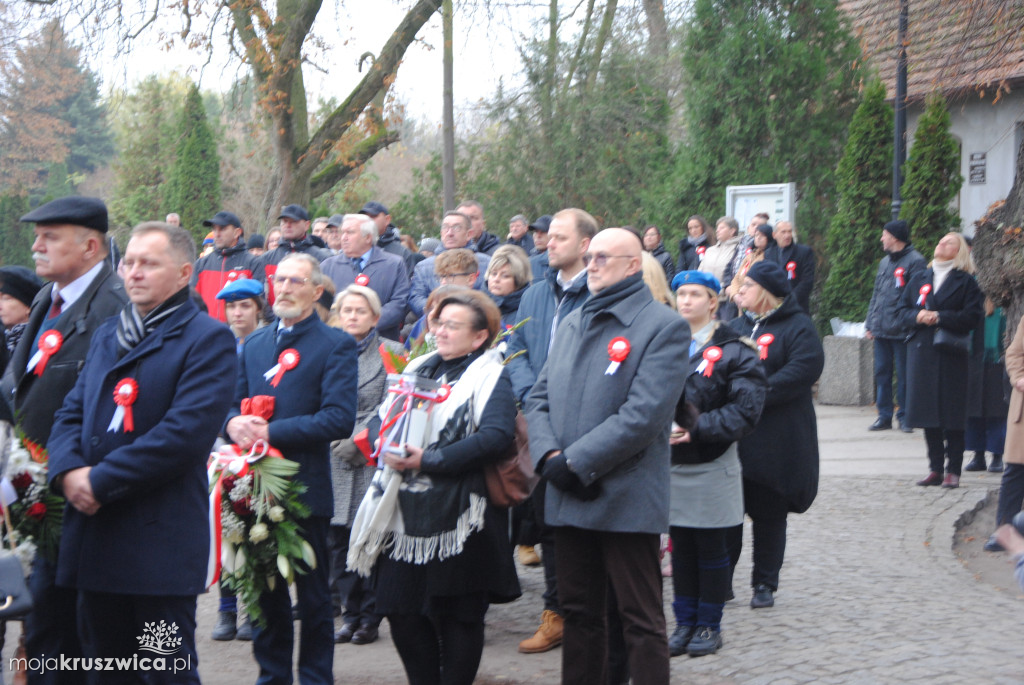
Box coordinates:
[729,261,824,609]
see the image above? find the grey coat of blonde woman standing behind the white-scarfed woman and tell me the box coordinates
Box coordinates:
[331,333,406,525]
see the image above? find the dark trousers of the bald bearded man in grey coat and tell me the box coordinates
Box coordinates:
[555,526,669,685]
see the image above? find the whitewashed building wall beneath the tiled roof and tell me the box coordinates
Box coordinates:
[907,90,1024,236]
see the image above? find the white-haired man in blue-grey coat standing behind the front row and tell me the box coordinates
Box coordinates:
[322,214,409,340]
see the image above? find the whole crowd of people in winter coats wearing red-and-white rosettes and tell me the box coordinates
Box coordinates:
[0,191,1024,685]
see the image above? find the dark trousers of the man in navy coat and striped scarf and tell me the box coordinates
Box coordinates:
[78,591,200,685]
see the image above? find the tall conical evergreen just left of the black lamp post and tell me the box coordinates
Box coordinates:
[818,80,893,322]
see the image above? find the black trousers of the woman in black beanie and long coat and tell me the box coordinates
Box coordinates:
[726,478,790,592]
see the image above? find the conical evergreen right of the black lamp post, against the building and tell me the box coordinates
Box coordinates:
[899,92,964,249]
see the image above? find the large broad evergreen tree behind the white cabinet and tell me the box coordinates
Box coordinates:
[657,0,860,241]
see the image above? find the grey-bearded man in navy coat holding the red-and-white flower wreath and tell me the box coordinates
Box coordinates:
[226,253,357,685]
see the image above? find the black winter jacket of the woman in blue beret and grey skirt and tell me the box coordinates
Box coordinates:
[672,324,768,464]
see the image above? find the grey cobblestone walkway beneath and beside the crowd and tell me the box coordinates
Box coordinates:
[4,406,1024,685]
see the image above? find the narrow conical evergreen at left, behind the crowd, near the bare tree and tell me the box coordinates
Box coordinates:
[164,84,220,242]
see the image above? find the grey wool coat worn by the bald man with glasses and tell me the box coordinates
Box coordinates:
[526,278,690,533]
